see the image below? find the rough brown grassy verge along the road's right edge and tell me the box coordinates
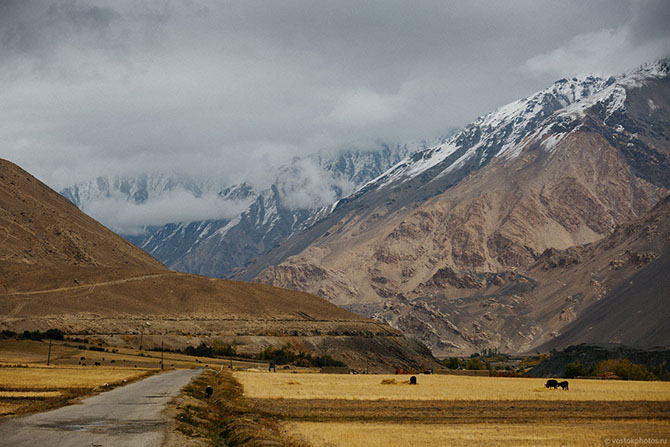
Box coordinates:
[177,370,306,447]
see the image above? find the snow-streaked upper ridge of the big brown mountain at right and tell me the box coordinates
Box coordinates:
[370,58,670,192]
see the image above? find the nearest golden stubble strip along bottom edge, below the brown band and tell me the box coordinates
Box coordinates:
[287,421,670,447]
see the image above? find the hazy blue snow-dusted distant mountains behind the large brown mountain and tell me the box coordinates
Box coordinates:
[61,145,414,277]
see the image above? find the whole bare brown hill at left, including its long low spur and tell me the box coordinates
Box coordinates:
[0,160,434,371]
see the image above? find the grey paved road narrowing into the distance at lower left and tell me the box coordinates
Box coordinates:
[0,370,200,447]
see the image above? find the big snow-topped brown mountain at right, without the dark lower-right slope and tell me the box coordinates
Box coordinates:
[247,61,670,355]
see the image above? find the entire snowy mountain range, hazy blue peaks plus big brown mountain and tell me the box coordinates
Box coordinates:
[63,60,670,356]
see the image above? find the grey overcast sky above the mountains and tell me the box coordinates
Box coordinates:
[0,0,670,189]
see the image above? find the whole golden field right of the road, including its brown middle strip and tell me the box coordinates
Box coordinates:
[234,372,670,447]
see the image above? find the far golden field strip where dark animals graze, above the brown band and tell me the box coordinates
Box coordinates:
[235,372,670,401]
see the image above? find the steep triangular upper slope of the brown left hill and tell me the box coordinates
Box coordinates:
[0,160,166,270]
